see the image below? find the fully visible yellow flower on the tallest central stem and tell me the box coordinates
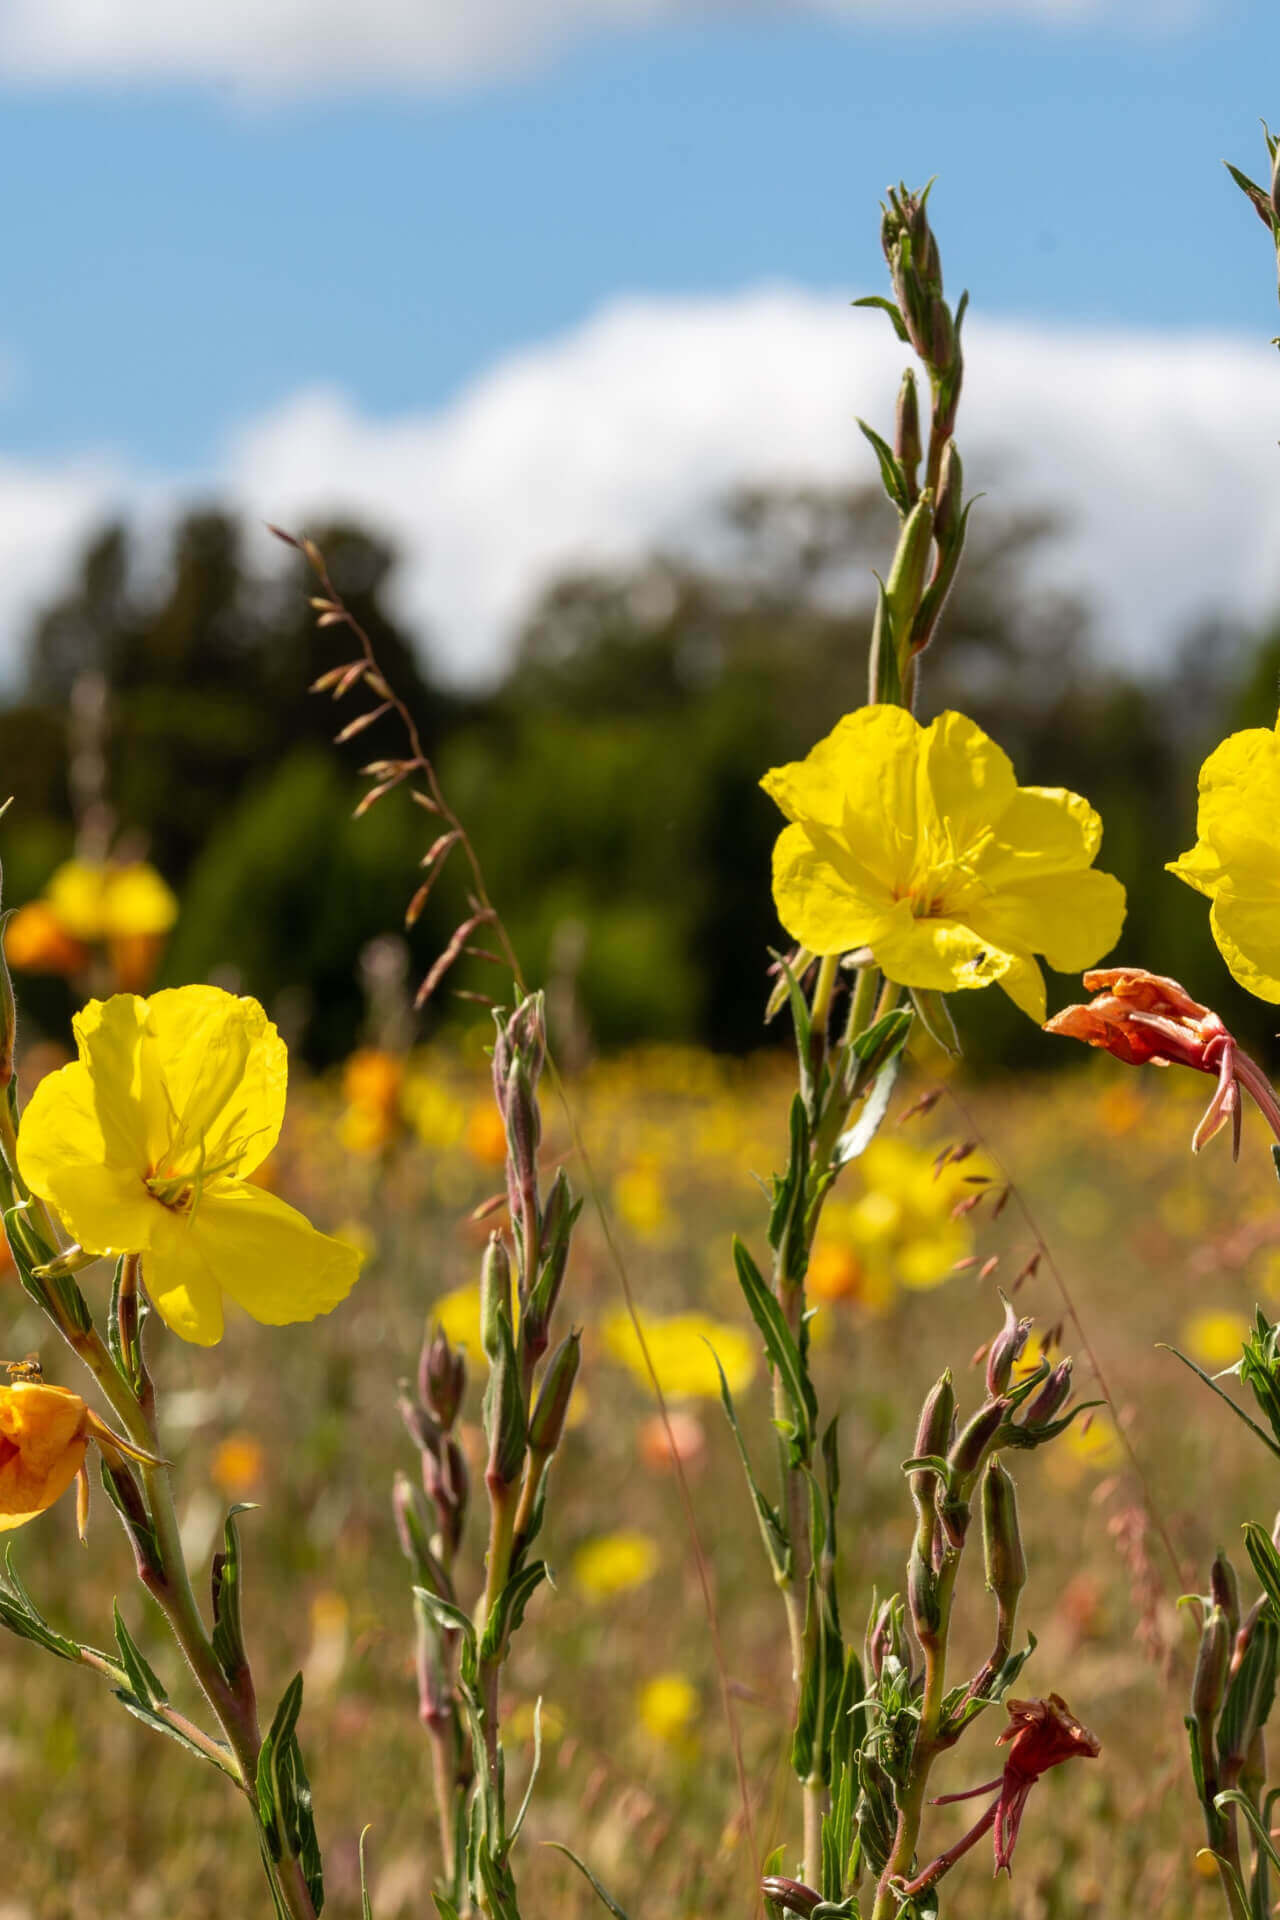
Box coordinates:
[762,707,1128,1021]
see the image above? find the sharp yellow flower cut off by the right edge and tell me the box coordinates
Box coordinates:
[1167,720,1280,1000]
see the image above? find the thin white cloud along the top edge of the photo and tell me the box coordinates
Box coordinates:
[0,0,1201,94]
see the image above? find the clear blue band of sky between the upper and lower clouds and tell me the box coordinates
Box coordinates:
[0,0,1280,470]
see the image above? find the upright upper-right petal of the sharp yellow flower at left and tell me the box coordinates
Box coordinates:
[142,987,288,1177]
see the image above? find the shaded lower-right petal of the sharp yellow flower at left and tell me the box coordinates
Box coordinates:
[190,1183,361,1327]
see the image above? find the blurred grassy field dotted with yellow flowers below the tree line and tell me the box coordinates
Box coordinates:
[0,1031,1280,1920]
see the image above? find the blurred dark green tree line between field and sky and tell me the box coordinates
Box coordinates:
[0,488,1280,1064]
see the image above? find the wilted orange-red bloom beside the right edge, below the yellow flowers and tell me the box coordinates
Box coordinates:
[1044,968,1280,1160]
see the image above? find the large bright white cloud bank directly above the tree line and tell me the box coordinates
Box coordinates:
[0,290,1280,680]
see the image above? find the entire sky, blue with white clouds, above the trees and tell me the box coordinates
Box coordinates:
[0,0,1280,674]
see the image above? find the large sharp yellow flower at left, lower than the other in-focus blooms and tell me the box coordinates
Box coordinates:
[17,987,361,1346]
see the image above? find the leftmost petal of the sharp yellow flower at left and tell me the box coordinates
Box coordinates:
[17,1062,163,1254]
